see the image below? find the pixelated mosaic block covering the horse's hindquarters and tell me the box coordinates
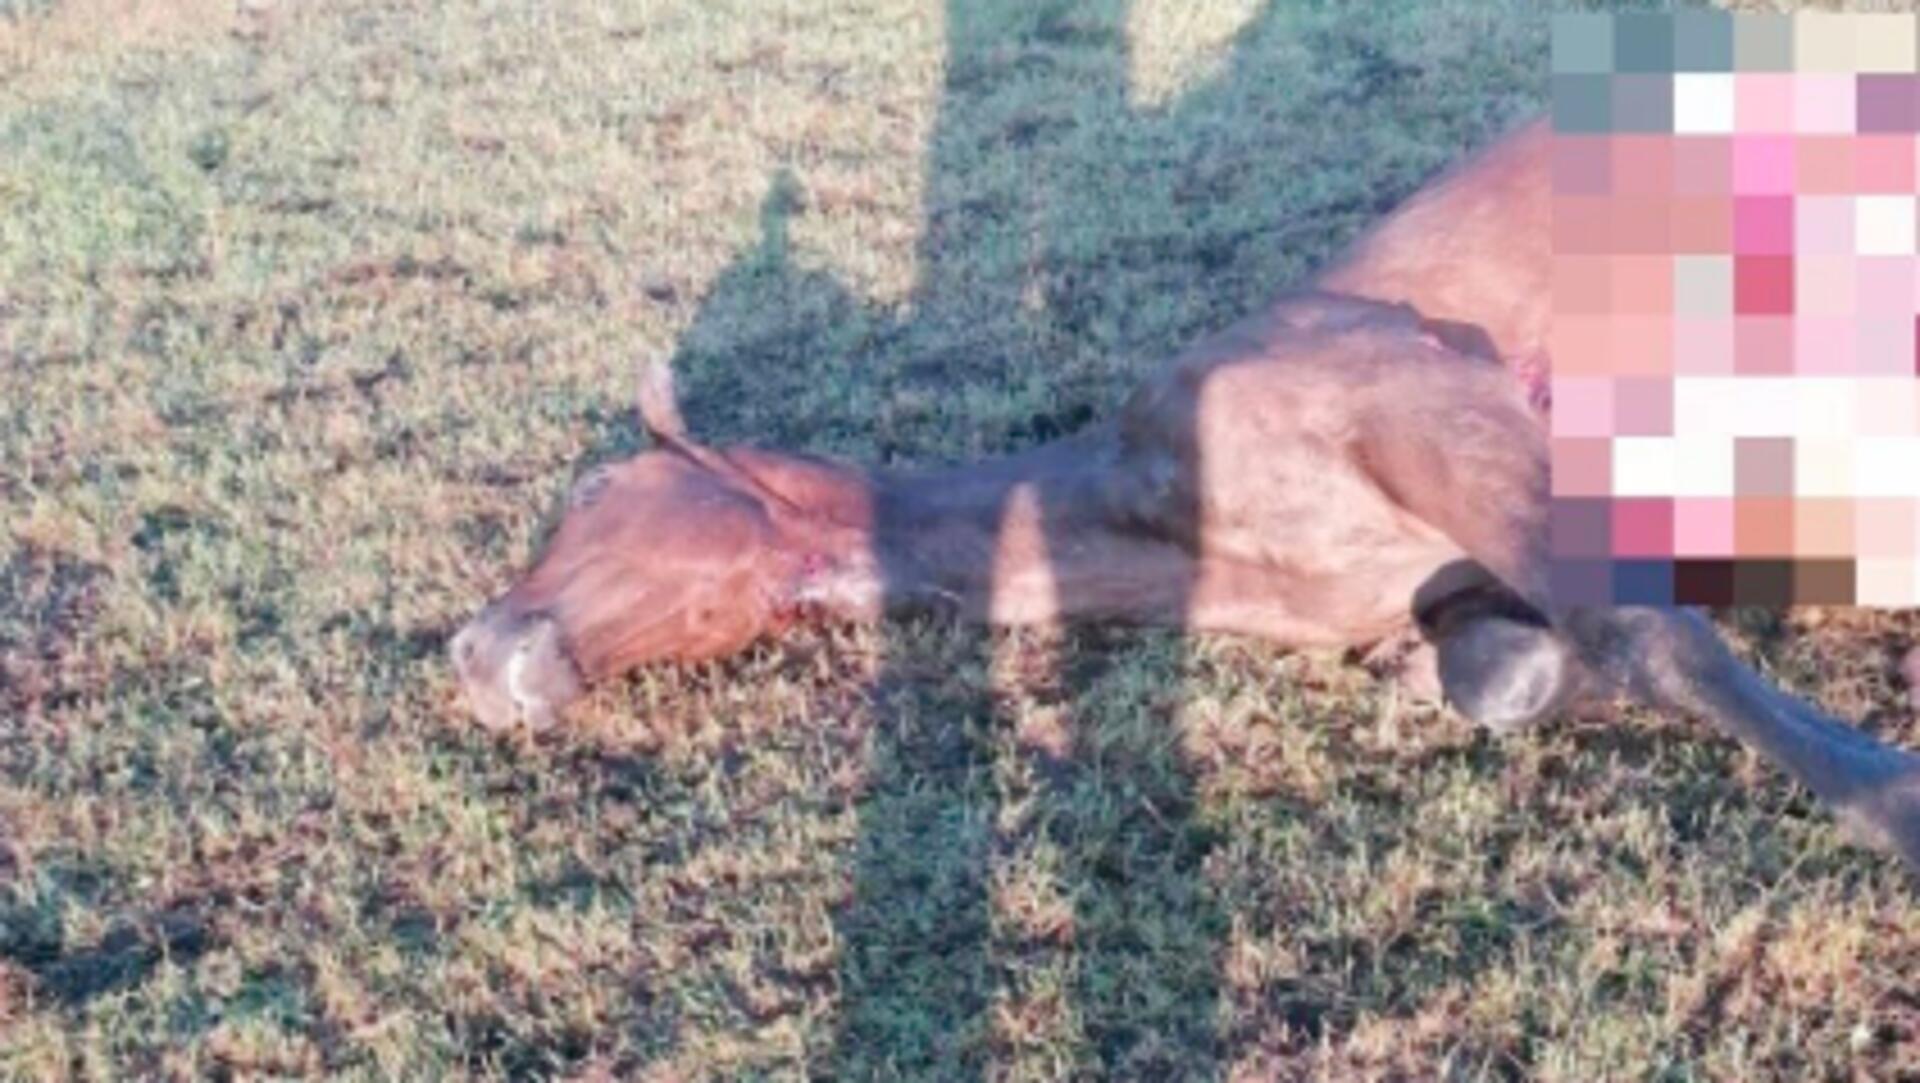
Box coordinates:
[1551,12,1920,607]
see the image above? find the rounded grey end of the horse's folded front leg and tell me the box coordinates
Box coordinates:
[1440,616,1572,734]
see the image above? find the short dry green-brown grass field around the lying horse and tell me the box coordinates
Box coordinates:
[0,0,1920,1081]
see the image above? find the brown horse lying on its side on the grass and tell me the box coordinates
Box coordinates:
[451,121,1920,875]
